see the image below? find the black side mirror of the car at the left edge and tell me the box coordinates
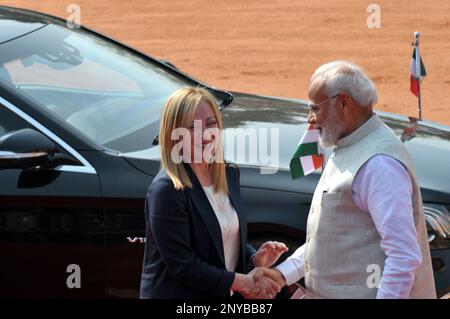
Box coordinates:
[0,128,56,169]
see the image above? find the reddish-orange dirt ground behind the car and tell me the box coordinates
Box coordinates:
[0,0,450,125]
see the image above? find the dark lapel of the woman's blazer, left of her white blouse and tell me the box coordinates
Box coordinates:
[185,165,225,267]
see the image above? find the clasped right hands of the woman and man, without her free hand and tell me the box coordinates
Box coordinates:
[231,268,281,299]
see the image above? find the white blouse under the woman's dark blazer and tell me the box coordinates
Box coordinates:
[203,185,240,271]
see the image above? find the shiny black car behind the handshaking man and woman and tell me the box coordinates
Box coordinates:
[0,7,450,298]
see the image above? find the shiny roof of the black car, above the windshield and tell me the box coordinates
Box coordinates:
[0,6,53,44]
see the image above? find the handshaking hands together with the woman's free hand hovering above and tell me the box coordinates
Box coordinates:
[231,242,288,299]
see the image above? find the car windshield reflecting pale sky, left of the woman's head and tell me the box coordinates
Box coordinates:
[0,24,191,152]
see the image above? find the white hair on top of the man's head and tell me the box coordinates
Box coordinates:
[311,61,378,106]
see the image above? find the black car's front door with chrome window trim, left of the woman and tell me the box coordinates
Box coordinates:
[0,101,105,298]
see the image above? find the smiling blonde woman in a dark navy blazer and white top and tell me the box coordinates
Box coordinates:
[140,87,287,299]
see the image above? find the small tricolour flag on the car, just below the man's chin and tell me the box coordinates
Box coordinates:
[289,124,323,179]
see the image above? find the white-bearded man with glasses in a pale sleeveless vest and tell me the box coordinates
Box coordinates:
[260,61,436,298]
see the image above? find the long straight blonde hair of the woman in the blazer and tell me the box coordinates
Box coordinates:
[159,87,228,194]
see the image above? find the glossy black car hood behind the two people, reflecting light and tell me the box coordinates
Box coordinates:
[124,92,450,203]
